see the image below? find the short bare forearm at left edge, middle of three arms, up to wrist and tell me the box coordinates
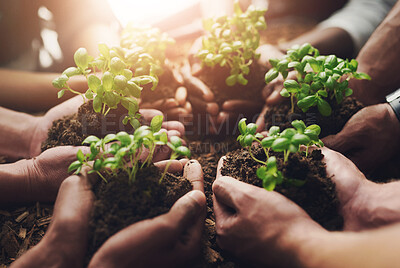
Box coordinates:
[0,107,39,161]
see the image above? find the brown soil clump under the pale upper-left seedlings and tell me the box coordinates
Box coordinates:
[42,100,137,151]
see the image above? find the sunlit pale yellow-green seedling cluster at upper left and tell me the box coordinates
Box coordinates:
[53,28,171,129]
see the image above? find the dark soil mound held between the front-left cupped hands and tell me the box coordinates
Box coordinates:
[87,165,192,260]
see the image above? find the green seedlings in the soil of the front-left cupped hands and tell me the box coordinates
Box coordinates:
[68,115,190,183]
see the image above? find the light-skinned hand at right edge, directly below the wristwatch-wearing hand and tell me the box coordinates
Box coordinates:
[321,147,400,231]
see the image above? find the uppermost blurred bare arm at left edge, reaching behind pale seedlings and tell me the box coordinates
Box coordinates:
[0,69,87,112]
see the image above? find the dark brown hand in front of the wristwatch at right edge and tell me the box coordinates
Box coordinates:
[323,104,400,172]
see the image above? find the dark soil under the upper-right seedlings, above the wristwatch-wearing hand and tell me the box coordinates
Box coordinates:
[265,97,364,138]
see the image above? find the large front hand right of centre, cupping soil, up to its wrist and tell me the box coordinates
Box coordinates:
[213,158,325,267]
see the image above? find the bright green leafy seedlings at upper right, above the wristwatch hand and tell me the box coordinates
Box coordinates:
[265,43,371,116]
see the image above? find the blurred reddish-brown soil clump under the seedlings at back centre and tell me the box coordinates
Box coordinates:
[198,62,266,105]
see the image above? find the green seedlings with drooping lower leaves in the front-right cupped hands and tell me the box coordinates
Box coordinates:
[237,118,324,191]
